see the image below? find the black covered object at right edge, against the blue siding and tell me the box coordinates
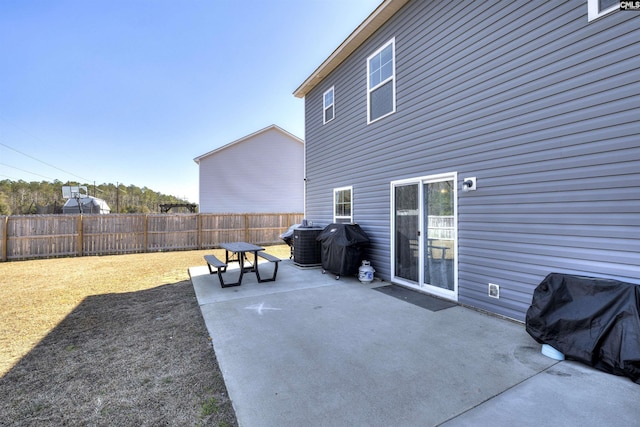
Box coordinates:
[526,273,640,384]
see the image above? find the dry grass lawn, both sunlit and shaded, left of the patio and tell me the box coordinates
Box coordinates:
[0,245,289,426]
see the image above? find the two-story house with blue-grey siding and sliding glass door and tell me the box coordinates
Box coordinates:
[294,0,640,321]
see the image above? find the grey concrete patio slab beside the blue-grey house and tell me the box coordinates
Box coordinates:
[189,260,640,427]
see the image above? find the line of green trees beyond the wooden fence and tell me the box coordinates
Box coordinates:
[0,180,195,215]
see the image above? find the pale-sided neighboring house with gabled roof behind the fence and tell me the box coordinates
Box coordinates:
[194,125,304,213]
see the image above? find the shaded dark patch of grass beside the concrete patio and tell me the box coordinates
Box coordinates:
[0,281,237,426]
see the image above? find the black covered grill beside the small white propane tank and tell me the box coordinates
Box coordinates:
[316,223,369,276]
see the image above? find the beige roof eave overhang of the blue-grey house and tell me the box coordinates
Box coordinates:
[293,0,409,98]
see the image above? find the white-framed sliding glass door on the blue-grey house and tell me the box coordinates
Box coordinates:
[390,172,458,301]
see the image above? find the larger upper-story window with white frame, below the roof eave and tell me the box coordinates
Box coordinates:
[367,38,396,123]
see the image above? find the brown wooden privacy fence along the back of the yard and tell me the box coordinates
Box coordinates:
[0,213,303,261]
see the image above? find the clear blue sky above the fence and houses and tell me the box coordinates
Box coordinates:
[0,0,381,202]
